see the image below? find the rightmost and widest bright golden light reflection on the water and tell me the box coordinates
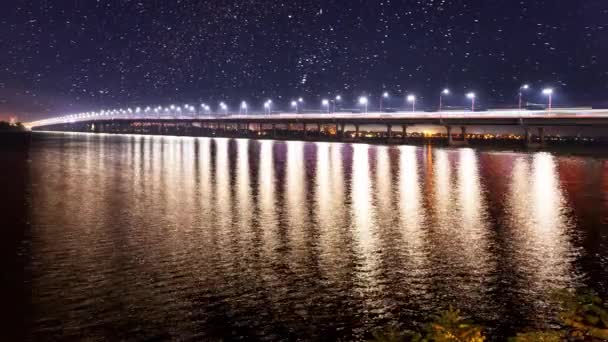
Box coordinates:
[507,153,576,314]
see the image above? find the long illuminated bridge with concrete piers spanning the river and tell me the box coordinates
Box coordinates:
[26,108,608,146]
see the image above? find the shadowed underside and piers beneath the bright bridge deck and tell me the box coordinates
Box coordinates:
[33,117,608,146]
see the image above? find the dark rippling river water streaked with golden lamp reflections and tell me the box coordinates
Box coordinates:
[0,134,608,340]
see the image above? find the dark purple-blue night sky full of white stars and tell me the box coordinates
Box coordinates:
[0,0,608,121]
